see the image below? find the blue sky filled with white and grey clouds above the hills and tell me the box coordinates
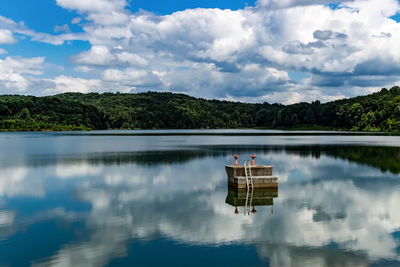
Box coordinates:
[0,0,400,104]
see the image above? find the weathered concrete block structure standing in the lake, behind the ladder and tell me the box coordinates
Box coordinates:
[225,165,278,188]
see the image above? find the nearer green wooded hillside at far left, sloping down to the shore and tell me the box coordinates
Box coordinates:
[0,95,107,131]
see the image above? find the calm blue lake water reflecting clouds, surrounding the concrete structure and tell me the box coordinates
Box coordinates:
[0,131,400,266]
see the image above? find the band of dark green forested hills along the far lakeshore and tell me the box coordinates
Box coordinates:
[0,86,400,131]
